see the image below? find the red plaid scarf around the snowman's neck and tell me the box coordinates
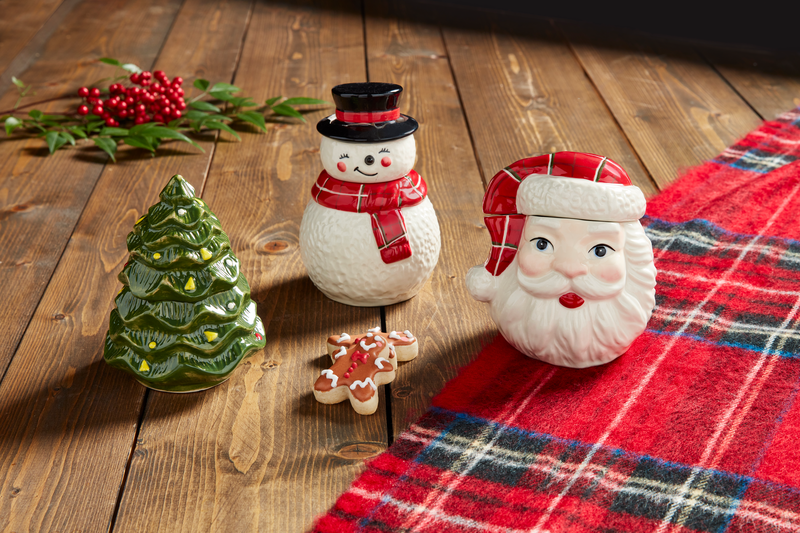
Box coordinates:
[311,170,428,264]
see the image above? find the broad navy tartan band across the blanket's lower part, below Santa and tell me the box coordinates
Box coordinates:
[382,407,800,532]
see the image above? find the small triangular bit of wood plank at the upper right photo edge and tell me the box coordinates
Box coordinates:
[697,46,800,120]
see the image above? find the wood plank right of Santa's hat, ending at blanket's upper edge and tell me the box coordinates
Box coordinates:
[558,23,761,187]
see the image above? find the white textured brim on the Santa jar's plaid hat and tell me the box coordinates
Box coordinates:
[517,175,647,222]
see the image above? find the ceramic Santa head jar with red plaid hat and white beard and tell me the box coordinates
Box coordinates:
[467,152,656,368]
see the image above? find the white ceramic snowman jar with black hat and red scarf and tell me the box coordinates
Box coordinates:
[300,83,441,306]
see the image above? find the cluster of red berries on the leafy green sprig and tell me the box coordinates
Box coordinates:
[78,70,186,126]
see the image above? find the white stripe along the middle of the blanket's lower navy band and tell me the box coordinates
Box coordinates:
[392,425,800,529]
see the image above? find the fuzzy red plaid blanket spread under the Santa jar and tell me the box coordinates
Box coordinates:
[315,110,800,533]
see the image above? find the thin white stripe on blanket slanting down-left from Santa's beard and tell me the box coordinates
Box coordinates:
[403,367,557,529]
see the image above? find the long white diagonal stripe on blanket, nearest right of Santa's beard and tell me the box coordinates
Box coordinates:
[532,183,800,533]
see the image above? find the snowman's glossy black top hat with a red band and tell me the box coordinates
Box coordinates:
[317,82,419,142]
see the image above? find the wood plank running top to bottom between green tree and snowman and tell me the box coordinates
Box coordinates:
[116,0,387,533]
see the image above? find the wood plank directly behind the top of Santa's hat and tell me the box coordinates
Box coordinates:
[444,12,657,196]
